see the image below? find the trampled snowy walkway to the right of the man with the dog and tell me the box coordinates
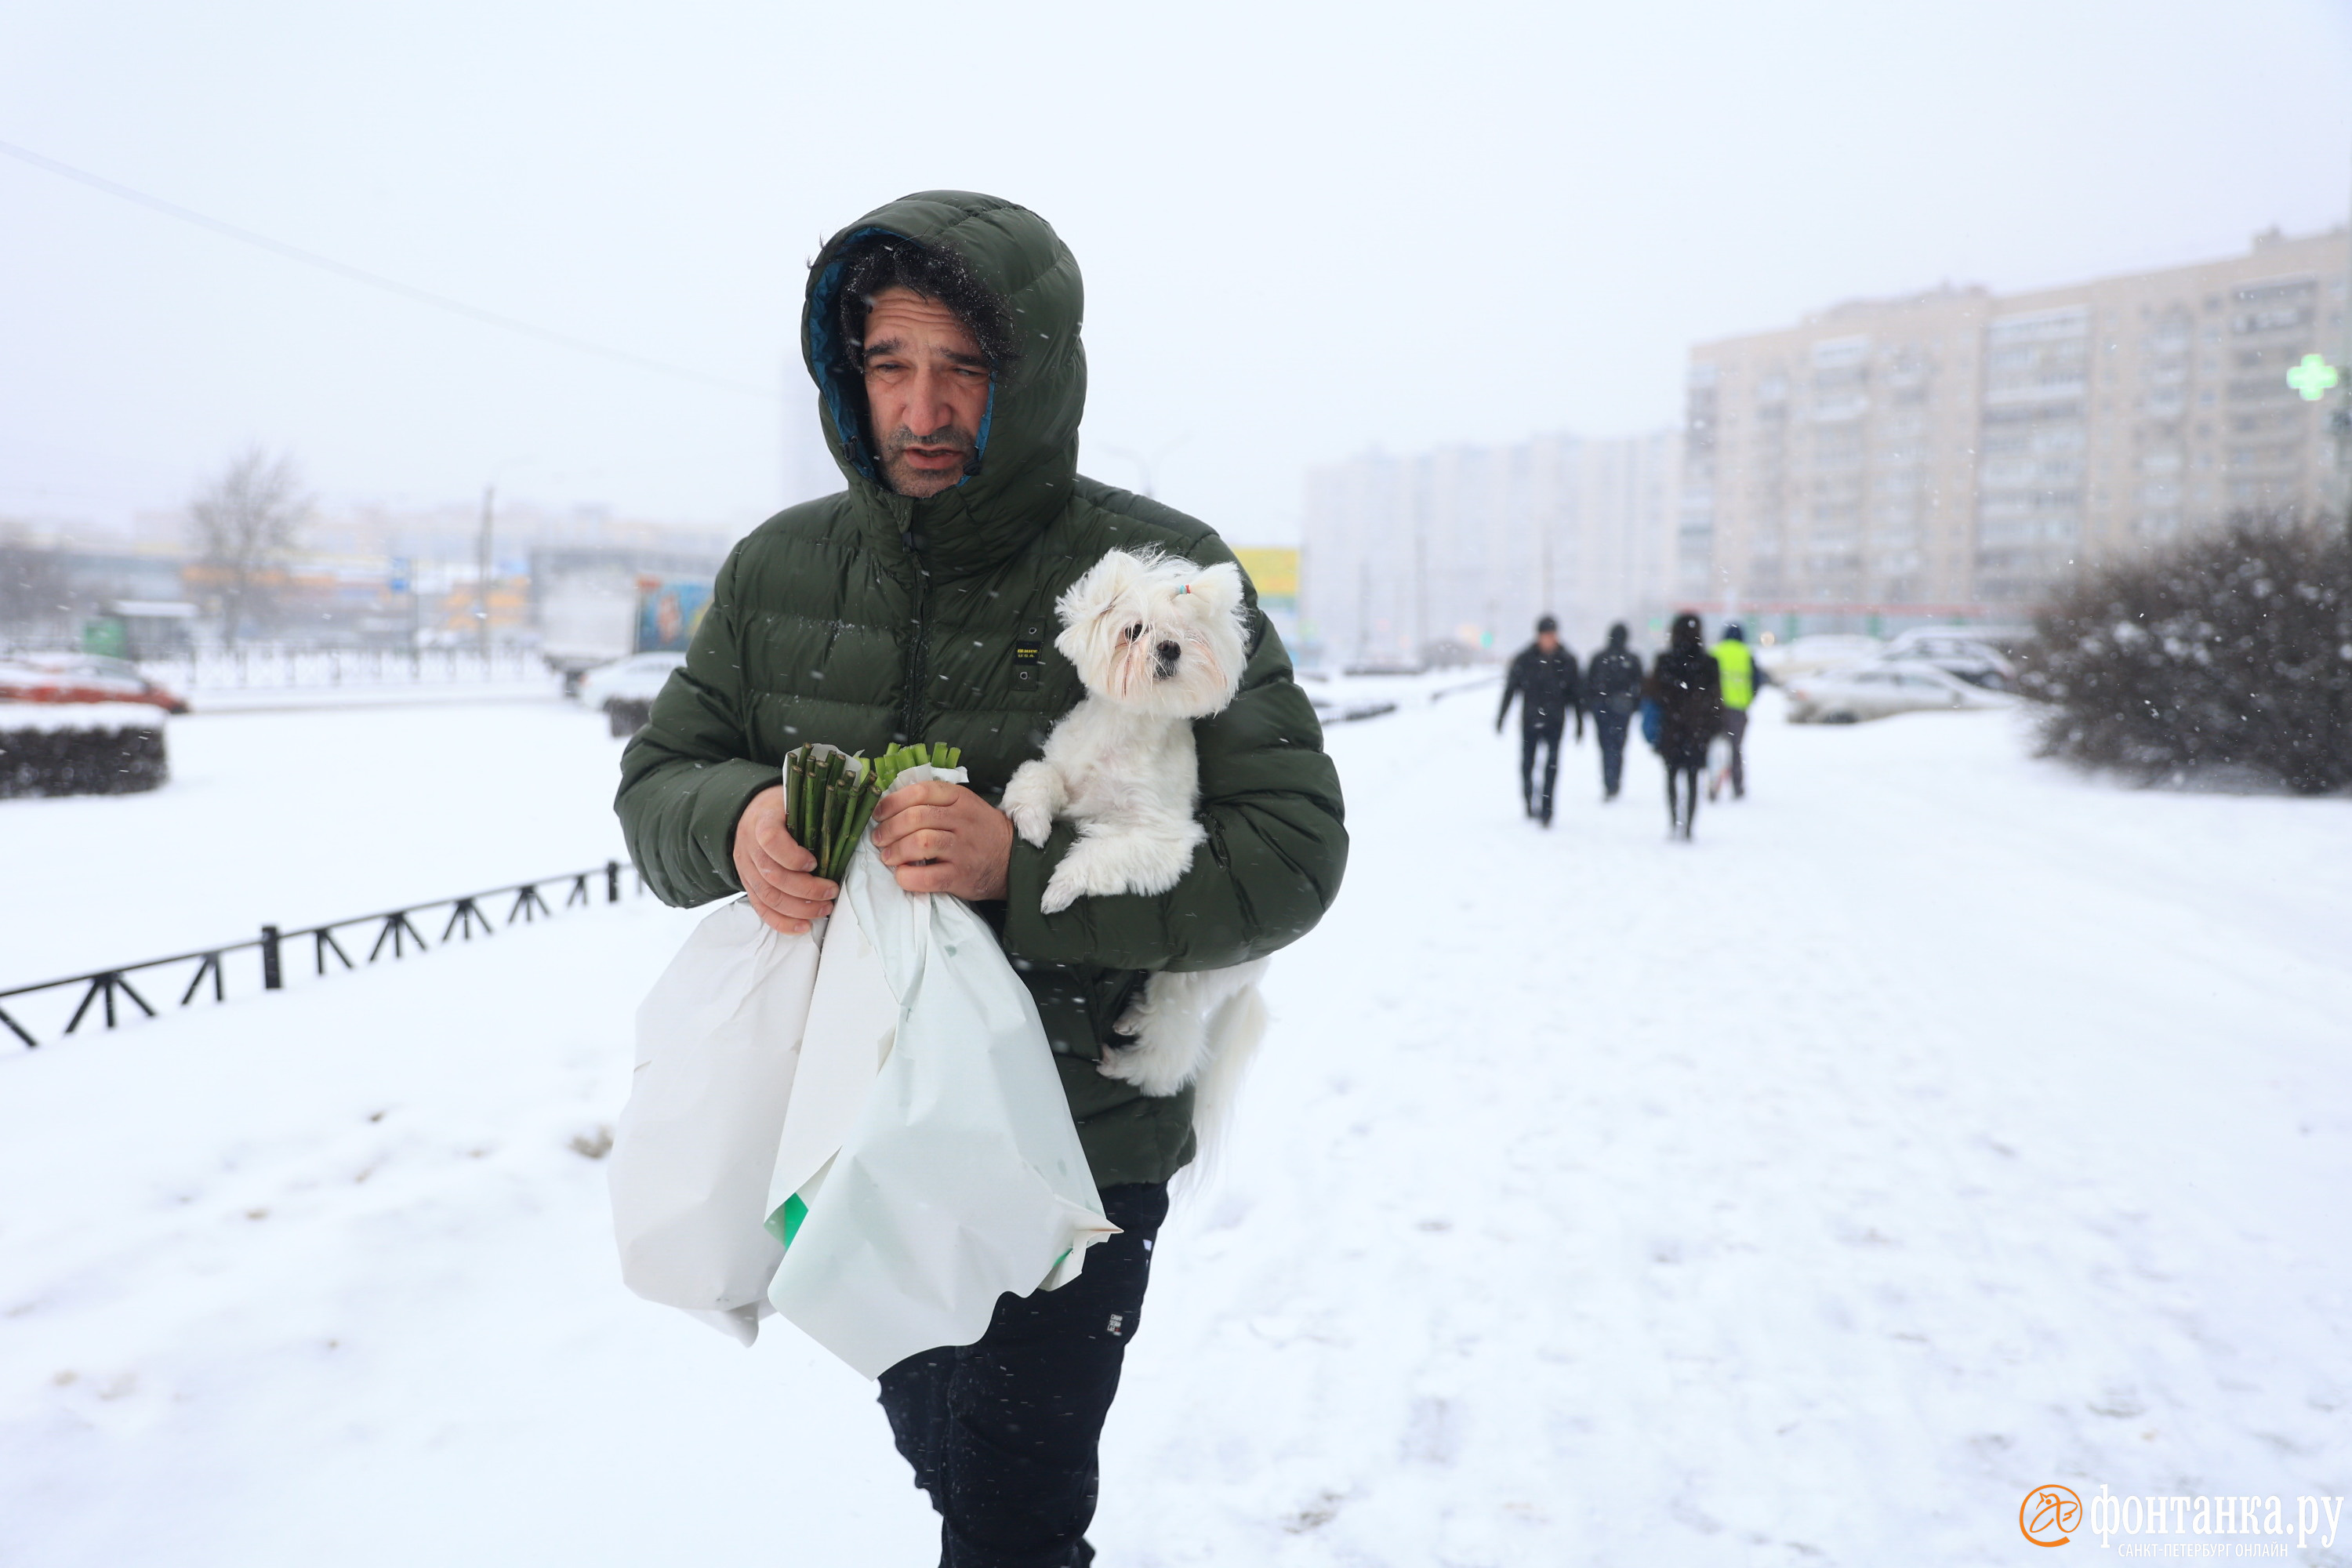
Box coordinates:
[1101,703,2352,1568]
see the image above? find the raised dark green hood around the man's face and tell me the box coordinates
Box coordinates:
[800,191,1087,574]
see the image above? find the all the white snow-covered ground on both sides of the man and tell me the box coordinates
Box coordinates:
[0,689,2352,1568]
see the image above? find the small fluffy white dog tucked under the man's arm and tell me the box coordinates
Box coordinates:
[1002,550,1265,1145]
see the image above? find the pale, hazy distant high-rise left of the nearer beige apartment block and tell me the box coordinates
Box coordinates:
[1298,430,1682,666]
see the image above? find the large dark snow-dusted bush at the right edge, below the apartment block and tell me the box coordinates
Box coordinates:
[2023,515,2352,794]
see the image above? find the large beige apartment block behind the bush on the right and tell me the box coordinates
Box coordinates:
[1672,228,2352,630]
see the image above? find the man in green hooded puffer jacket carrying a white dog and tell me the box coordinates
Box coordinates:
[619,191,1348,1568]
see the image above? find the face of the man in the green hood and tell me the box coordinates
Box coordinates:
[866,289,988,496]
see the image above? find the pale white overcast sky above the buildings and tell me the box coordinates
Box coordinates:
[0,0,2352,543]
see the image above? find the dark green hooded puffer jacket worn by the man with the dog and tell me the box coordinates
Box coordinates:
[616,191,1348,1187]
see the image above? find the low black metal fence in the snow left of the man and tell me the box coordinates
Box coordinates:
[0,860,644,1051]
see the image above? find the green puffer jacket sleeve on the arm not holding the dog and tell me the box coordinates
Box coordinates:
[614,546,779,907]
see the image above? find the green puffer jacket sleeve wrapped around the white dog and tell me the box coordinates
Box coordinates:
[1004,616,1348,968]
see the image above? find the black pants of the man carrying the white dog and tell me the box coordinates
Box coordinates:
[882,1182,1169,1568]
